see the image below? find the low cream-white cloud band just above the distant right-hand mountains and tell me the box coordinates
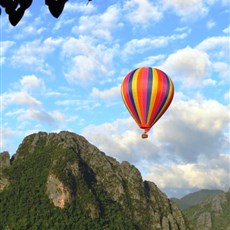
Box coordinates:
[144,155,230,196]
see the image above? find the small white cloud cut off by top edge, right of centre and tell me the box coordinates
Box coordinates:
[124,0,163,26]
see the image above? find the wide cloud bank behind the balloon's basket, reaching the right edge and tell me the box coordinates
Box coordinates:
[83,97,229,162]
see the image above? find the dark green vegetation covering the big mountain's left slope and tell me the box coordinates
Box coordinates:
[0,136,134,229]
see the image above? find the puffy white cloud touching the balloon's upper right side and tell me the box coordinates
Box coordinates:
[162,47,211,87]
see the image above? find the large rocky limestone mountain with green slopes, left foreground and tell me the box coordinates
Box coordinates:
[0,131,191,230]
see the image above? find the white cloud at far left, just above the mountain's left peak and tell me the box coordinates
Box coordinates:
[2,75,66,132]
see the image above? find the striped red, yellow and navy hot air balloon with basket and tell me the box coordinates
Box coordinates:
[121,67,174,138]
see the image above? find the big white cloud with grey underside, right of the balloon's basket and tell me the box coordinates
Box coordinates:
[155,99,229,162]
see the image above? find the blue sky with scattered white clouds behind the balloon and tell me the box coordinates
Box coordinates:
[1,0,230,197]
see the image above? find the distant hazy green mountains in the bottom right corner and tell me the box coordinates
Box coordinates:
[171,189,230,230]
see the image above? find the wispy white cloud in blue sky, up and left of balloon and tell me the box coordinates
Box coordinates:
[62,37,117,85]
